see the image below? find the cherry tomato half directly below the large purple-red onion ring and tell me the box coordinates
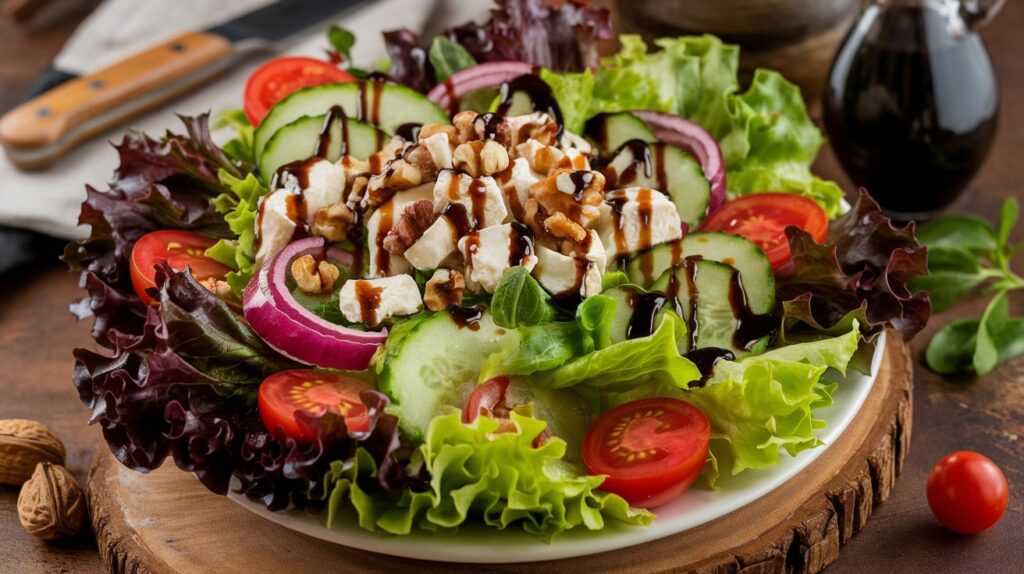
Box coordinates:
[259,368,370,442]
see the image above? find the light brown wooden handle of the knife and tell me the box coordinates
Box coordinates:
[0,32,232,169]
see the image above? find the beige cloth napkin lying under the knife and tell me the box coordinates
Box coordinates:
[0,0,490,238]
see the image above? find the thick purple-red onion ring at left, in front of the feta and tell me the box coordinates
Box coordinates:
[243,237,387,370]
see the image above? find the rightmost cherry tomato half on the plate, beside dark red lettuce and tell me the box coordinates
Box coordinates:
[700,193,828,269]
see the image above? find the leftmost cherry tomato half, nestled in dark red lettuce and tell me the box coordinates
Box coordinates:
[130,229,230,305]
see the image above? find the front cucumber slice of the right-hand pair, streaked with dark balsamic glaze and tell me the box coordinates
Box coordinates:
[653,259,768,357]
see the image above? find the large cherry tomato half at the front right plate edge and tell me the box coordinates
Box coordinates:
[583,397,711,509]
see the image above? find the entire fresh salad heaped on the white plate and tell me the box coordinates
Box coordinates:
[65,0,930,540]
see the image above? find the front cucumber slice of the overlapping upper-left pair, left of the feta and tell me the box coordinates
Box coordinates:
[259,115,388,181]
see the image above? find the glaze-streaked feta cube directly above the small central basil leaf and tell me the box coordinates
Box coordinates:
[459,219,537,293]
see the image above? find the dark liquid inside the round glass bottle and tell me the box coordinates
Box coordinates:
[824,6,998,219]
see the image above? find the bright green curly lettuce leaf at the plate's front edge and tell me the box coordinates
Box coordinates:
[324,411,653,541]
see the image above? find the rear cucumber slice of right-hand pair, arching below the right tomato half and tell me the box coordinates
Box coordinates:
[626,231,775,315]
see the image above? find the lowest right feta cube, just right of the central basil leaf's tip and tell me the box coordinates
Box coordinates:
[534,230,605,299]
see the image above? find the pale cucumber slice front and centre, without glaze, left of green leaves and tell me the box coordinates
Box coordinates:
[377,311,504,441]
